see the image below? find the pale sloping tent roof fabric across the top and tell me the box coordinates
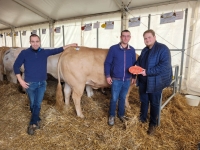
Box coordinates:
[0,0,191,30]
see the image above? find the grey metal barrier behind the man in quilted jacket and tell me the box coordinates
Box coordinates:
[157,65,179,126]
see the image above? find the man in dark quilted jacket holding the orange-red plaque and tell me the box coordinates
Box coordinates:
[136,30,172,134]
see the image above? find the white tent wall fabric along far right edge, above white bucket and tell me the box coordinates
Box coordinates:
[184,0,200,96]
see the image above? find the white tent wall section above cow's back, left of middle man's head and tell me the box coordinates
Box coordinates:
[83,13,121,48]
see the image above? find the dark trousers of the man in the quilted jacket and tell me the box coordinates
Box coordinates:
[139,83,162,126]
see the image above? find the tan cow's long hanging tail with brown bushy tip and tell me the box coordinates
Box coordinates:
[56,53,64,110]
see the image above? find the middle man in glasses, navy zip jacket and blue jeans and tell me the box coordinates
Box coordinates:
[104,30,136,126]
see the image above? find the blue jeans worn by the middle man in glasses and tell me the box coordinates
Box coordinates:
[109,79,131,117]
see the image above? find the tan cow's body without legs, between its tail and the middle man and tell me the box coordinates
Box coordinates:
[60,47,108,88]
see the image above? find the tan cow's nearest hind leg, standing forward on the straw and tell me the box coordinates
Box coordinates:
[72,83,85,118]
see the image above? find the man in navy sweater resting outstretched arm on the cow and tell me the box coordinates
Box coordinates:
[13,34,77,135]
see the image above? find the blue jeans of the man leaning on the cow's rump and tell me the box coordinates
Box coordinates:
[26,81,47,125]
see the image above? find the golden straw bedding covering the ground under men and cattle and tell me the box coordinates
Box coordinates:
[0,80,200,150]
